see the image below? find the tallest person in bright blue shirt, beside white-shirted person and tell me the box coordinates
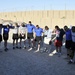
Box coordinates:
[26,21,35,47]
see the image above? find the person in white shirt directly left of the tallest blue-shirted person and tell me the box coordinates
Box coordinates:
[19,23,27,49]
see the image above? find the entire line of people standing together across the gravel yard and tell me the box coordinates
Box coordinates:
[0,21,75,63]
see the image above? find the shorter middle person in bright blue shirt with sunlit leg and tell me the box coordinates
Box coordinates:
[34,25,43,51]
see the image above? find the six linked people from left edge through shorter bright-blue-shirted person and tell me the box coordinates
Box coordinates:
[0,21,43,51]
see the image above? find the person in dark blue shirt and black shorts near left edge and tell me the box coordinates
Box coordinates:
[2,24,12,51]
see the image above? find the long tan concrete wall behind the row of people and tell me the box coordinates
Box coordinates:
[0,10,75,28]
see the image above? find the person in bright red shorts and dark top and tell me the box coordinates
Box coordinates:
[55,26,65,56]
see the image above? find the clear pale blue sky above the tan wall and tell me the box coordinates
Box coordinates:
[0,0,75,12]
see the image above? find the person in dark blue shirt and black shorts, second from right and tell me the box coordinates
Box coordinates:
[64,26,72,59]
